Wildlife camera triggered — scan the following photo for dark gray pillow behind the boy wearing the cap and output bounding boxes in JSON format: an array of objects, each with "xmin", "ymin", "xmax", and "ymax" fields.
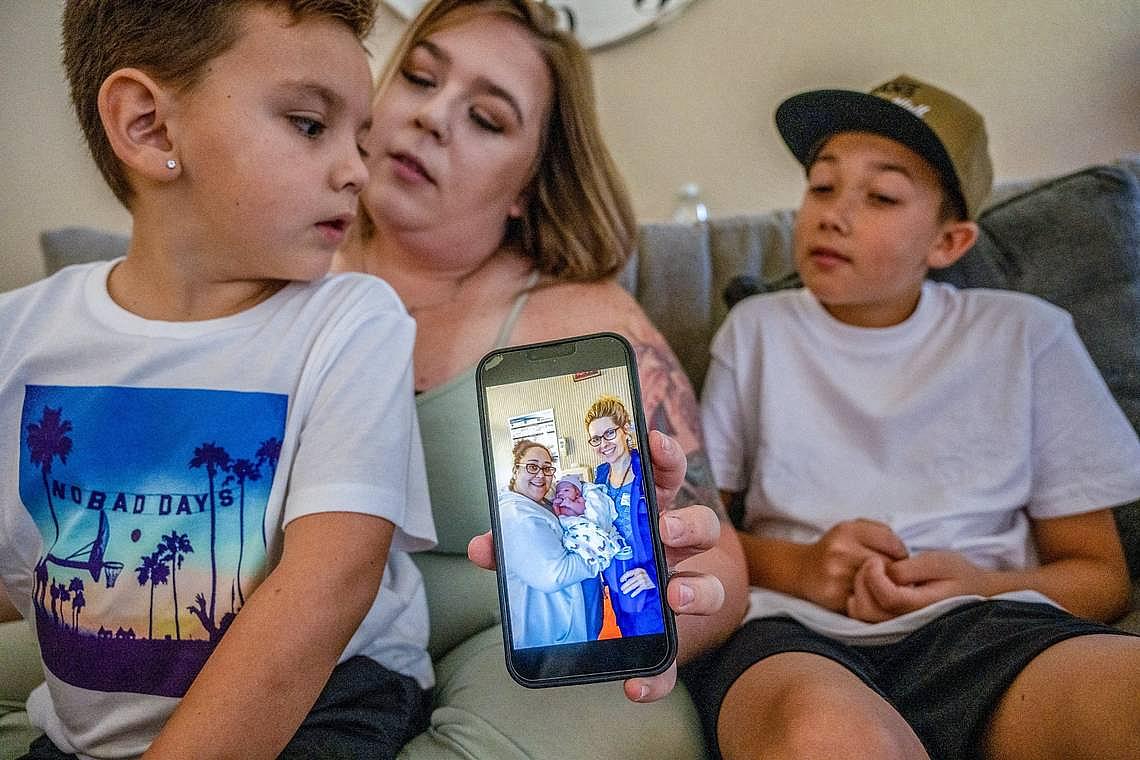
[{"xmin": 931, "ymin": 166, "xmax": 1140, "ymax": 578}]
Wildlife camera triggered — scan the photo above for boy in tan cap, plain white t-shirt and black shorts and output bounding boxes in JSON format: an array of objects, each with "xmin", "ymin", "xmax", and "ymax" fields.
[{"xmin": 686, "ymin": 76, "xmax": 1140, "ymax": 758}]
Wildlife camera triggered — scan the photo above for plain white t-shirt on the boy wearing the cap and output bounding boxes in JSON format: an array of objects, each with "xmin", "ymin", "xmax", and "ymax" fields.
[{"xmin": 701, "ymin": 283, "xmax": 1140, "ymax": 641}]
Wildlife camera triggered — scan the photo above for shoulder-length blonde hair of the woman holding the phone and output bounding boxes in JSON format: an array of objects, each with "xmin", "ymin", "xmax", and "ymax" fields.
[{"xmin": 360, "ymin": 0, "xmax": 637, "ymax": 281}]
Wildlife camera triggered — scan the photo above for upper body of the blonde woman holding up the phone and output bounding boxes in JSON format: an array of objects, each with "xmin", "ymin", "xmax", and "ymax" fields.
[{"xmin": 340, "ymin": 0, "xmax": 746, "ymax": 701}]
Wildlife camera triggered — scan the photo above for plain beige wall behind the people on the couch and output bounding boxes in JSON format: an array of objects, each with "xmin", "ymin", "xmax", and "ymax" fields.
[{"xmin": 0, "ymin": 0, "xmax": 1140, "ymax": 291}]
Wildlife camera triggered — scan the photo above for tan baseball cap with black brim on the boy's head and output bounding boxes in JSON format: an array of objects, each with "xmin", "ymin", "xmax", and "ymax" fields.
[{"xmin": 775, "ymin": 74, "xmax": 993, "ymax": 220}]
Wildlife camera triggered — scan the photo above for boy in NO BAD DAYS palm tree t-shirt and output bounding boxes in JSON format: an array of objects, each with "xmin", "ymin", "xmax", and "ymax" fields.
[{"xmin": 0, "ymin": 0, "xmax": 434, "ymax": 758}]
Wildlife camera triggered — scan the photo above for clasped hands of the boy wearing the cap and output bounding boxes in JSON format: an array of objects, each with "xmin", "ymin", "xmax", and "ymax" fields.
[{"xmin": 800, "ymin": 518, "xmax": 983, "ymax": 623}]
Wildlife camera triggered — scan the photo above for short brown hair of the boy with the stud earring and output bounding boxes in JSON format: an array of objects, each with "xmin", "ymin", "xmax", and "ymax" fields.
[{"xmin": 63, "ymin": 0, "xmax": 378, "ymax": 207}]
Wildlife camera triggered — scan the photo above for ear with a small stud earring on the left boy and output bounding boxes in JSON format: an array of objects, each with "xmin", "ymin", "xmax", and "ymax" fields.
[{"xmin": 98, "ymin": 68, "xmax": 181, "ymax": 181}]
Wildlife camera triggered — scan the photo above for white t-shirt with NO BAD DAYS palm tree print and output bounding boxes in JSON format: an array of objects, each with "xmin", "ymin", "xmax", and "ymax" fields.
[{"xmin": 0, "ymin": 262, "xmax": 435, "ymax": 757}]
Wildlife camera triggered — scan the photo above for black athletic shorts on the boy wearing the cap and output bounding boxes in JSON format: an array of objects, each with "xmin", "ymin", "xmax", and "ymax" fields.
[{"xmin": 681, "ymin": 600, "xmax": 1131, "ymax": 760}]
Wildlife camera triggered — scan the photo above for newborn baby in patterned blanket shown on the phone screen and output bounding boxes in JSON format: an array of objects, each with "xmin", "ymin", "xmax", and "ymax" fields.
[{"xmin": 552, "ymin": 475, "xmax": 634, "ymax": 572}]
